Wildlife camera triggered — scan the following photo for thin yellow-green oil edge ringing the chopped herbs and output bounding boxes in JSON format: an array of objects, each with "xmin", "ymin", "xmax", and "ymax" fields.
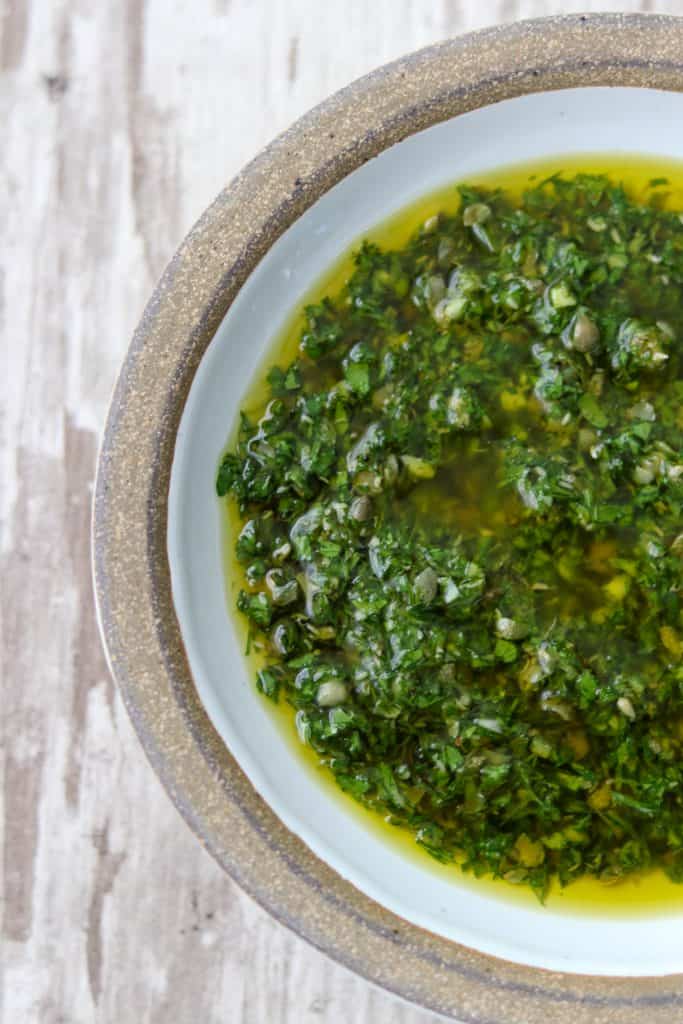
[{"xmin": 221, "ymin": 154, "xmax": 683, "ymax": 916}]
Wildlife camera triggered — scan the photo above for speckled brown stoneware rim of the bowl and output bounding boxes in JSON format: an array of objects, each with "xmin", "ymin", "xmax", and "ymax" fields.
[{"xmin": 92, "ymin": 14, "xmax": 683, "ymax": 1024}]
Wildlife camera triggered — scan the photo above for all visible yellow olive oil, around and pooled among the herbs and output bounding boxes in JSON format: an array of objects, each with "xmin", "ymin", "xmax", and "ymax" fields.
[{"xmin": 224, "ymin": 155, "xmax": 683, "ymax": 915}]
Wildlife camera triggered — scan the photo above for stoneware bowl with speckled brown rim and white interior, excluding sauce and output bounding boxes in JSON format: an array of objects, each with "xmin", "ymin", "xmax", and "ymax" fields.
[{"xmin": 93, "ymin": 15, "xmax": 683, "ymax": 1024}]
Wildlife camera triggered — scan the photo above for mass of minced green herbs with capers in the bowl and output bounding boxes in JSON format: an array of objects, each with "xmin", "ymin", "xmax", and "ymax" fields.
[{"xmin": 217, "ymin": 174, "xmax": 683, "ymax": 897}]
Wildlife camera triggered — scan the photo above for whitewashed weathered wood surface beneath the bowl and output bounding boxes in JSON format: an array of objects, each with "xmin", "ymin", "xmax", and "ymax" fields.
[{"xmin": 0, "ymin": 0, "xmax": 683, "ymax": 1024}]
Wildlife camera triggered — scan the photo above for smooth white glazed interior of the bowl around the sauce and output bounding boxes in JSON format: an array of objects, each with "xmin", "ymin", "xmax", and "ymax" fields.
[{"xmin": 168, "ymin": 88, "xmax": 683, "ymax": 975}]
